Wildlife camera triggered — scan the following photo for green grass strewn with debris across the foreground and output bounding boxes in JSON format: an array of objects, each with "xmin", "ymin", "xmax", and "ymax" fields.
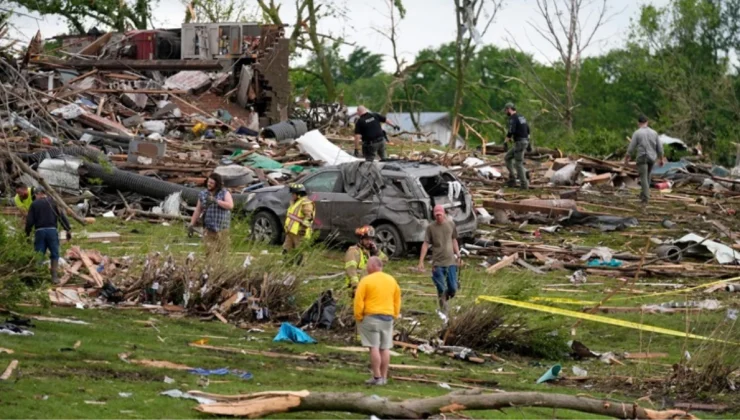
[{"xmin": 0, "ymin": 188, "xmax": 740, "ymax": 419}]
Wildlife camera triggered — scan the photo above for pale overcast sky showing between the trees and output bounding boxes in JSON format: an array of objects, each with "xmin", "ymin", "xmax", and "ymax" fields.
[{"xmin": 14, "ymin": 0, "xmax": 669, "ymax": 69}]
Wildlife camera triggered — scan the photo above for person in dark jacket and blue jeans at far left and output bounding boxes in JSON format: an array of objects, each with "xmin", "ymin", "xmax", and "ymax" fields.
[{"xmin": 26, "ymin": 187, "xmax": 72, "ymax": 284}]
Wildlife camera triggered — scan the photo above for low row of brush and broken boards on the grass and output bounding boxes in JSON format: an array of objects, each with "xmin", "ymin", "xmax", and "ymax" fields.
[{"xmin": 49, "ymin": 246, "xmax": 297, "ymax": 323}]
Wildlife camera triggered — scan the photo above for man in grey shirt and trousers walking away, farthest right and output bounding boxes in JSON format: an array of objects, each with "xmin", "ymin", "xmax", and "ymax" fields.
[{"xmin": 624, "ymin": 115, "xmax": 665, "ymax": 205}]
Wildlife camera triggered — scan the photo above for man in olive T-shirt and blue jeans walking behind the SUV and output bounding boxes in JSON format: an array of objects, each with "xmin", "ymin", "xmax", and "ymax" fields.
[{"xmin": 419, "ymin": 204, "xmax": 460, "ymax": 313}]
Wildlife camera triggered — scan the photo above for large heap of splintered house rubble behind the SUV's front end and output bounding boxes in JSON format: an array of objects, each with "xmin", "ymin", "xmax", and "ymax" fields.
[{"xmin": 0, "ymin": 25, "xmax": 364, "ymax": 220}]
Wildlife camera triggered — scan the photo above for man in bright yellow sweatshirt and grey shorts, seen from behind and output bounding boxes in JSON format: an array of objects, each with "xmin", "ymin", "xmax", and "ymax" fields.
[{"xmin": 355, "ymin": 257, "xmax": 401, "ymax": 385}]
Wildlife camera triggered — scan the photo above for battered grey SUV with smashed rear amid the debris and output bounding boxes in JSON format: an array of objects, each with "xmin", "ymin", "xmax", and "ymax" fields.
[{"xmin": 245, "ymin": 161, "xmax": 477, "ymax": 257}]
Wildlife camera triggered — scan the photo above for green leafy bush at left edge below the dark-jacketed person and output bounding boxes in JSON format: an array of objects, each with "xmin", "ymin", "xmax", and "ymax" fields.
[{"xmin": 0, "ymin": 219, "xmax": 49, "ymax": 306}]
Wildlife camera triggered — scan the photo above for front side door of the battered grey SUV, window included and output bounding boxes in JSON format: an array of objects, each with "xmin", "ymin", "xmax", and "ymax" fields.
[{"xmin": 303, "ymin": 170, "xmax": 341, "ymax": 238}]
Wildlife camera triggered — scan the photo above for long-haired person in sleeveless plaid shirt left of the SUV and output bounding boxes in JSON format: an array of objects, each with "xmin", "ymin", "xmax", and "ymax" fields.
[{"xmin": 189, "ymin": 173, "xmax": 234, "ymax": 256}]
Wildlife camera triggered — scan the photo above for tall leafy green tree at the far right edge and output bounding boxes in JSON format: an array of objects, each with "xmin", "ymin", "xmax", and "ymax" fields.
[{"xmin": 633, "ymin": 0, "xmax": 740, "ymax": 163}]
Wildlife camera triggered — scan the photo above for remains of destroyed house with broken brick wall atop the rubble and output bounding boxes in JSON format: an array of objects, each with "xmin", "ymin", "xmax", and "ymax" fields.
[{"xmin": 39, "ymin": 22, "xmax": 290, "ymax": 127}]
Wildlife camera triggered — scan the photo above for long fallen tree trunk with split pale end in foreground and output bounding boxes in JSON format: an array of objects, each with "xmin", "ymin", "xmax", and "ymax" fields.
[{"xmin": 196, "ymin": 390, "xmax": 696, "ymax": 420}]
